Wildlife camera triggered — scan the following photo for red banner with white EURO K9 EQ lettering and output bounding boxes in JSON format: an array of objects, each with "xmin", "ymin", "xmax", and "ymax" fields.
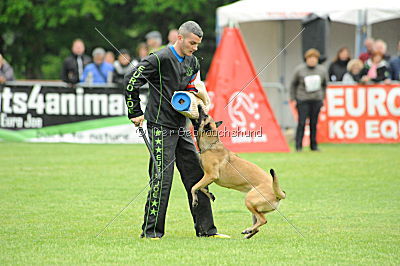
[{"xmin": 317, "ymin": 84, "xmax": 400, "ymax": 143}]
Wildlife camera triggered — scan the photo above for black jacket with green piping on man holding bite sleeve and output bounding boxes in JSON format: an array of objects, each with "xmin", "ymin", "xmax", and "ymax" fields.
[{"xmin": 124, "ymin": 47, "xmax": 200, "ymax": 128}]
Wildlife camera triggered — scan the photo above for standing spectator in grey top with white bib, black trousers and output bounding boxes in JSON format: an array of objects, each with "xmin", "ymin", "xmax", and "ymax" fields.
[{"xmin": 290, "ymin": 48, "xmax": 328, "ymax": 151}]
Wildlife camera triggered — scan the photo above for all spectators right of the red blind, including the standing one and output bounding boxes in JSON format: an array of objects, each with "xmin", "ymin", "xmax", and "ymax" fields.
[{"xmin": 290, "ymin": 39, "xmax": 400, "ymax": 152}]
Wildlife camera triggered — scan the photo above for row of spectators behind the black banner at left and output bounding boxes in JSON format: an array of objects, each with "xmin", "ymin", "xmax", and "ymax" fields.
[{"xmin": 61, "ymin": 29, "xmax": 178, "ymax": 87}]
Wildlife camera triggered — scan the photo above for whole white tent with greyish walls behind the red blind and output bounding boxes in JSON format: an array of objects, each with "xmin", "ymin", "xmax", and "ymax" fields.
[{"xmin": 217, "ymin": 0, "xmax": 400, "ymax": 126}]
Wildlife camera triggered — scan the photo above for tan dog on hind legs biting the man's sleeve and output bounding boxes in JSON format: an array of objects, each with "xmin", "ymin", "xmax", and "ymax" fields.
[{"xmin": 191, "ymin": 105, "xmax": 286, "ymax": 239}]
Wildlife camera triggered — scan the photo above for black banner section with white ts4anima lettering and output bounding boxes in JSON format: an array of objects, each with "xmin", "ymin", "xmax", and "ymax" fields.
[{"xmin": 0, "ymin": 81, "xmax": 147, "ymax": 130}]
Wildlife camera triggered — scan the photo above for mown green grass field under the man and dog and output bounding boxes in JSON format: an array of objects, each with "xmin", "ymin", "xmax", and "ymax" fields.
[{"xmin": 0, "ymin": 143, "xmax": 400, "ymax": 265}]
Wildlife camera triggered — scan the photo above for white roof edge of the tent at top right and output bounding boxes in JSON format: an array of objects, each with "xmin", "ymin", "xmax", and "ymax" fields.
[{"xmin": 217, "ymin": 0, "xmax": 400, "ymax": 27}]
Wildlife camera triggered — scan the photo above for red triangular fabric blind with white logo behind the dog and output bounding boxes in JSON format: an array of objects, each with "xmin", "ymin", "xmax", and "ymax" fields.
[{"xmin": 206, "ymin": 28, "xmax": 289, "ymax": 152}]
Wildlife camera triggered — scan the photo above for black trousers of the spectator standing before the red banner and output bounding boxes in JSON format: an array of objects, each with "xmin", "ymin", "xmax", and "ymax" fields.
[{"xmin": 296, "ymin": 100, "xmax": 322, "ymax": 150}]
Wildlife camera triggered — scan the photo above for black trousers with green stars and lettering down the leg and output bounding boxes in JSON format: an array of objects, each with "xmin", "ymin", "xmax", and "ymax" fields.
[{"xmin": 141, "ymin": 124, "xmax": 217, "ymax": 237}]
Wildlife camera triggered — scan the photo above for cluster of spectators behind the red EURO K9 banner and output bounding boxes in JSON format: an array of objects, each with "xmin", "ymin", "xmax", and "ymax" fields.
[{"xmin": 328, "ymin": 38, "xmax": 400, "ymax": 84}]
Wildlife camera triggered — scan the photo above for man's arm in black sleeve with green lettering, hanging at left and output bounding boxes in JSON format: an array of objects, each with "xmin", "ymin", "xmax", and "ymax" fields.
[{"xmin": 124, "ymin": 55, "xmax": 157, "ymax": 125}]
